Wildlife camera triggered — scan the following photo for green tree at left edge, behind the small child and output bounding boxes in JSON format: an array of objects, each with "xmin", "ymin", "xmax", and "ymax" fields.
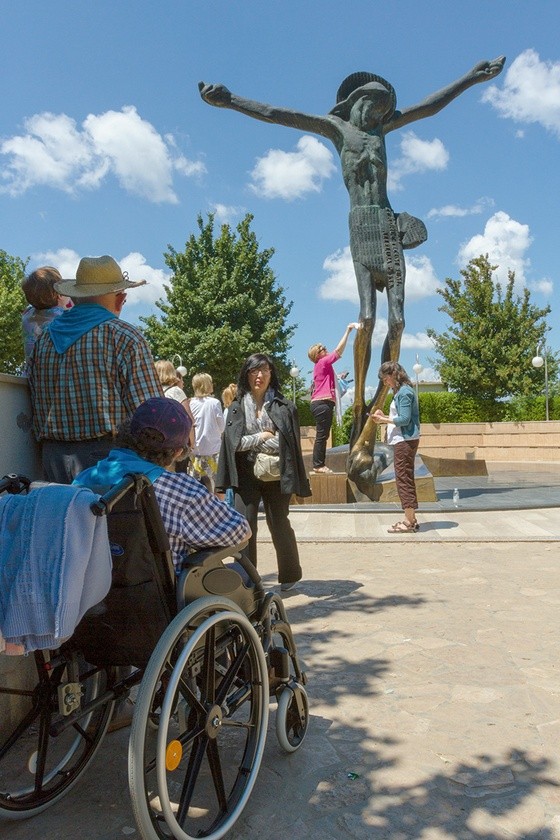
[{"xmin": 0, "ymin": 250, "xmax": 27, "ymax": 374}]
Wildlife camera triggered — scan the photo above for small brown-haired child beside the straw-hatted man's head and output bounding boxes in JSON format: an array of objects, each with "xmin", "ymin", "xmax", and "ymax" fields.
[{"xmin": 21, "ymin": 265, "xmax": 72, "ymax": 366}]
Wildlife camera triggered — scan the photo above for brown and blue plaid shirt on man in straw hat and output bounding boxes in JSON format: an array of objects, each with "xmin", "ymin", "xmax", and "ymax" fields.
[{"xmin": 29, "ymin": 318, "xmax": 163, "ymax": 441}]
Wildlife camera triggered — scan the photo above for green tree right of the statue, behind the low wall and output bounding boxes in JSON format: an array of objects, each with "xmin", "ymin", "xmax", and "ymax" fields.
[{"xmin": 427, "ymin": 255, "xmax": 558, "ymax": 400}]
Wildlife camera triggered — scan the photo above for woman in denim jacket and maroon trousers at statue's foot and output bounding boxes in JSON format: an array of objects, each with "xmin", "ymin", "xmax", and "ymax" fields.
[{"xmin": 371, "ymin": 362, "xmax": 420, "ymax": 534}]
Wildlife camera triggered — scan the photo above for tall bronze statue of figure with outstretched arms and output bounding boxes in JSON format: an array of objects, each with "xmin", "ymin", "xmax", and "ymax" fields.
[{"xmin": 198, "ymin": 57, "xmax": 505, "ymax": 495}]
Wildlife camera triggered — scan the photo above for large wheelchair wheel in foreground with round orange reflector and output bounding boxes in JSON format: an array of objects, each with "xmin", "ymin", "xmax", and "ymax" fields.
[{"xmin": 129, "ymin": 597, "xmax": 269, "ymax": 840}]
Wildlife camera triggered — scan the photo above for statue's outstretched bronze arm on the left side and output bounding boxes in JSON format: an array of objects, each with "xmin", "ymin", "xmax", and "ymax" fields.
[{"xmin": 198, "ymin": 82, "xmax": 335, "ymax": 140}]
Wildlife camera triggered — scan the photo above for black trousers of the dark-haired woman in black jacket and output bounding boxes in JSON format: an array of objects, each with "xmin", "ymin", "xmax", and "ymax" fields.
[{"xmin": 235, "ymin": 456, "xmax": 302, "ymax": 583}]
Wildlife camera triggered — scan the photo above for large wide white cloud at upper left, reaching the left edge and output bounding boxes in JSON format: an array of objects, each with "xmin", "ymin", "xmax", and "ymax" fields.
[{"xmin": 0, "ymin": 106, "xmax": 206, "ymax": 203}]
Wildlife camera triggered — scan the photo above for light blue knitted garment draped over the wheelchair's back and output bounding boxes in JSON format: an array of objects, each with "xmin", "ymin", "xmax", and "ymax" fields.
[{"xmin": 0, "ymin": 484, "xmax": 112, "ymax": 653}]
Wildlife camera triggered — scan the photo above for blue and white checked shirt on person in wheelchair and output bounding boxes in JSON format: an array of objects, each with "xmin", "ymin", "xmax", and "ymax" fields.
[{"xmin": 154, "ymin": 470, "xmax": 250, "ymax": 567}]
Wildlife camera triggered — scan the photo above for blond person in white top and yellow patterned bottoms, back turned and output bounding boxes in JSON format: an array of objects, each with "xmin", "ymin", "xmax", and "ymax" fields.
[{"xmin": 189, "ymin": 373, "xmax": 224, "ymax": 493}]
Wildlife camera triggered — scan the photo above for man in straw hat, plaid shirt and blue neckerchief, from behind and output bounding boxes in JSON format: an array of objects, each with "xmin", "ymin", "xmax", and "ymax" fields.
[{"xmin": 29, "ymin": 256, "xmax": 162, "ymax": 484}]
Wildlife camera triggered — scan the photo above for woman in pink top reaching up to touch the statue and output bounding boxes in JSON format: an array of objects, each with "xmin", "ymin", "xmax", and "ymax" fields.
[{"xmin": 307, "ymin": 324, "xmax": 359, "ymax": 473}]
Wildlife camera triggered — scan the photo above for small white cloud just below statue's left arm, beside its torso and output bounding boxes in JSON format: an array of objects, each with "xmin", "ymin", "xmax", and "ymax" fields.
[{"xmin": 250, "ymin": 135, "xmax": 336, "ymax": 201}]
